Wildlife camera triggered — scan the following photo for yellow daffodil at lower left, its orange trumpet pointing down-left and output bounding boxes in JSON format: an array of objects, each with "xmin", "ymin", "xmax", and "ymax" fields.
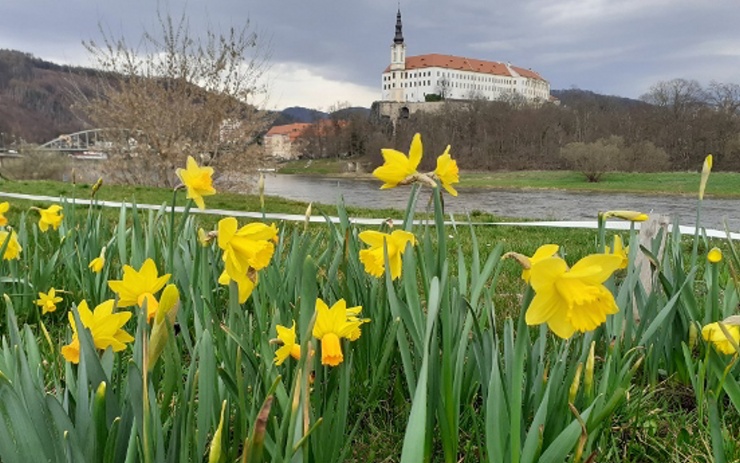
[{"xmin": 62, "ymin": 299, "xmax": 134, "ymax": 363}]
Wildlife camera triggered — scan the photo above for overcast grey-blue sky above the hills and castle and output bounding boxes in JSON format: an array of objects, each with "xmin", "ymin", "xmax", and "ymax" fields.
[{"xmin": 0, "ymin": 0, "xmax": 740, "ymax": 109}]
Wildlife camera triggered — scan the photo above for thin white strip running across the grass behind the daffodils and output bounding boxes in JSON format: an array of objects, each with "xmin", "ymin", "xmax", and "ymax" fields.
[{"xmin": 0, "ymin": 191, "xmax": 740, "ymax": 240}]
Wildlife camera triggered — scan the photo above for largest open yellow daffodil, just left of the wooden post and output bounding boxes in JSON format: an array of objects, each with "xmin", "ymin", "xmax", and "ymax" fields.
[{"xmin": 525, "ymin": 254, "xmax": 622, "ymax": 339}]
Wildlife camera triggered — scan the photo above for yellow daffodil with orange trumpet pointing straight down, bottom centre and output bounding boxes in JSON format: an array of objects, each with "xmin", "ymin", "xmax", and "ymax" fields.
[{"xmin": 313, "ymin": 299, "xmax": 361, "ymax": 367}]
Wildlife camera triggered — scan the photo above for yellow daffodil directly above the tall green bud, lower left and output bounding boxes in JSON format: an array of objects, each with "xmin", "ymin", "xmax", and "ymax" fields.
[{"xmin": 108, "ymin": 259, "xmax": 170, "ymax": 321}]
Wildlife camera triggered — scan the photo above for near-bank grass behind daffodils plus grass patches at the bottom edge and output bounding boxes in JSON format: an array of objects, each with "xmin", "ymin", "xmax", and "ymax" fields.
[{"xmin": 0, "ymin": 179, "xmax": 740, "ymax": 462}]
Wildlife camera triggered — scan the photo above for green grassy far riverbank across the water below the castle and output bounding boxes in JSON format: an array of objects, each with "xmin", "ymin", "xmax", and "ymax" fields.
[{"xmin": 278, "ymin": 158, "xmax": 740, "ymax": 198}]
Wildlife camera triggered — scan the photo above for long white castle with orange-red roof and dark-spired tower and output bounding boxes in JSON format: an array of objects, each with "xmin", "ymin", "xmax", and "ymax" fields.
[{"xmin": 381, "ymin": 9, "xmax": 550, "ymax": 102}]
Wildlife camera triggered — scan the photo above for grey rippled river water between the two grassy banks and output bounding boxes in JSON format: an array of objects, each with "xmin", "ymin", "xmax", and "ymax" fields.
[{"xmin": 265, "ymin": 174, "xmax": 740, "ymax": 232}]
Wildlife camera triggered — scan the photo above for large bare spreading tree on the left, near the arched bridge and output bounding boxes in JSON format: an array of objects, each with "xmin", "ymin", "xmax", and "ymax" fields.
[{"xmin": 77, "ymin": 7, "xmax": 268, "ymax": 185}]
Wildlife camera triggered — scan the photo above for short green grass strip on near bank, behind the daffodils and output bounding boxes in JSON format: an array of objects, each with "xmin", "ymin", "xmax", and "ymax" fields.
[{"xmin": 0, "ymin": 177, "xmax": 726, "ymax": 322}]
